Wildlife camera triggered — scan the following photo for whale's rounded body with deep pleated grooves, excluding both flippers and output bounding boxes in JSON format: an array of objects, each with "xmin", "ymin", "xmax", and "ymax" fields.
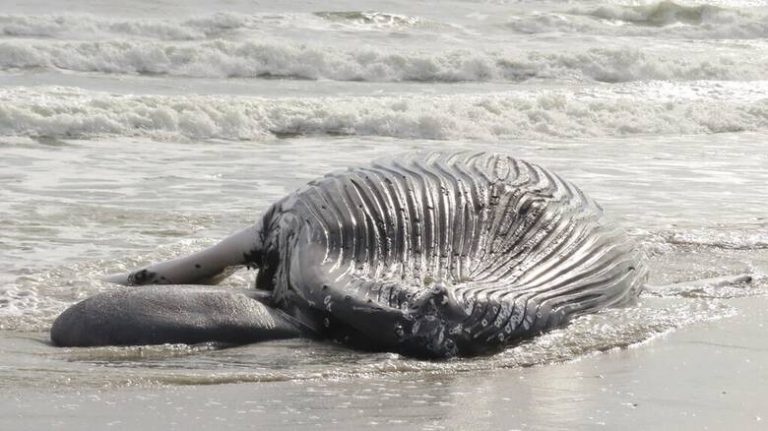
[{"xmin": 257, "ymin": 153, "xmax": 646, "ymax": 356}]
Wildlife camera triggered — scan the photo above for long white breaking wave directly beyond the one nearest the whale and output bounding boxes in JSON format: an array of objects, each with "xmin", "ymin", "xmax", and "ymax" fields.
[{"xmin": 0, "ymin": 40, "xmax": 768, "ymax": 82}]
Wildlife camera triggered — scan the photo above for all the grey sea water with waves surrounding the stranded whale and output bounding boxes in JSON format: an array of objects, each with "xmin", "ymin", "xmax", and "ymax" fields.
[{"xmin": 0, "ymin": 0, "xmax": 768, "ymax": 428}]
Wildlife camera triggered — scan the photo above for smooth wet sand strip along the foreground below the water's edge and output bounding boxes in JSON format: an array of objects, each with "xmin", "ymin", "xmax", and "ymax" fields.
[{"xmin": 0, "ymin": 296, "xmax": 768, "ymax": 431}]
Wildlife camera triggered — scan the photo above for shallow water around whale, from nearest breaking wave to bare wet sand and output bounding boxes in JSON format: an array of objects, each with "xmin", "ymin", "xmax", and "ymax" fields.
[{"xmin": 0, "ymin": 134, "xmax": 768, "ymax": 387}]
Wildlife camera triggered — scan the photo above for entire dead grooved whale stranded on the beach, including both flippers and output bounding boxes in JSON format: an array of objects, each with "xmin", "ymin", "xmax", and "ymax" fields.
[{"xmin": 51, "ymin": 153, "xmax": 660, "ymax": 358}]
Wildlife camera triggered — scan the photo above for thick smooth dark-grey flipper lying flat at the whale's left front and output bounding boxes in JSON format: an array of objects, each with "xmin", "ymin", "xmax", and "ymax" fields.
[{"xmin": 51, "ymin": 286, "xmax": 303, "ymax": 346}]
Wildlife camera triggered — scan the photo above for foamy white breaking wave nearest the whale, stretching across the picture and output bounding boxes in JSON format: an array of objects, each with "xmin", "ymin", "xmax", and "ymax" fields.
[{"xmin": 0, "ymin": 83, "xmax": 768, "ymax": 140}]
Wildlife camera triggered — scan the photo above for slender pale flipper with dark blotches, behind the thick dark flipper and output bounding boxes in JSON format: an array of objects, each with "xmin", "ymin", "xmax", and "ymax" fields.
[{"xmin": 105, "ymin": 226, "xmax": 260, "ymax": 286}]
